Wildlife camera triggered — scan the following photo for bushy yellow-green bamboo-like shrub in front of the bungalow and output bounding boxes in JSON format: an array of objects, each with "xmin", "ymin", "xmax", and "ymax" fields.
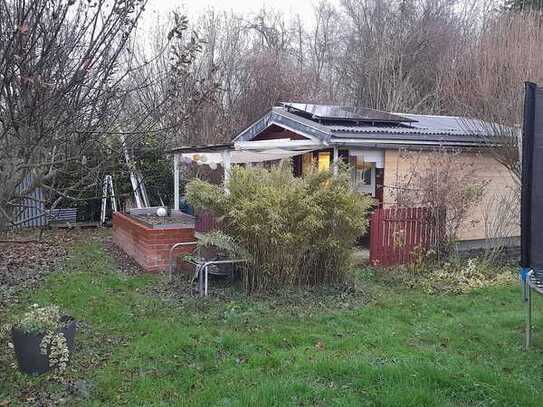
[{"xmin": 187, "ymin": 161, "xmax": 373, "ymax": 291}]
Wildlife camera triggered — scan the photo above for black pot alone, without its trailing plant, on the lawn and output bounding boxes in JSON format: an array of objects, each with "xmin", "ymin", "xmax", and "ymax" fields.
[{"xmin": 11, "ymin": 317, "xmax": 76, "ymax": 375}]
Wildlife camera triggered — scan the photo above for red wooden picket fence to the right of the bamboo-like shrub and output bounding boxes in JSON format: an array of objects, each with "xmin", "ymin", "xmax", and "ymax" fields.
[{"xmin": 370, "ymin": 208, "xmax": 446, "ymax": 266}]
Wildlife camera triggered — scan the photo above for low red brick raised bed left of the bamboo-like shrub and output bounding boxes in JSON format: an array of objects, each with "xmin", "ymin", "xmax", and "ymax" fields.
[{"xmin": 113, "ymin": 212, "xmax": 195, "ymax": 273}]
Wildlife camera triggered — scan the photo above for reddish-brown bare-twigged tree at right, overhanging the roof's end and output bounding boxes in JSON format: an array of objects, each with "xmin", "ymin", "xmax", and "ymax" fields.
[{"xmin": 438, "ymin": 12, "xmax": 543, "ymax": 182}]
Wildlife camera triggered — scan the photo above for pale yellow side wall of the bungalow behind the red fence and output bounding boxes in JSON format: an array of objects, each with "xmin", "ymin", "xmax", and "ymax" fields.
[{"xmin": 383, "ymin": 150, "xmax": 520, "ymax": 240}]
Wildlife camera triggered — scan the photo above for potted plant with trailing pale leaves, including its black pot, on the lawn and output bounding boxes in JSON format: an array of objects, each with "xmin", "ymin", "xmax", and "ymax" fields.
[{"xmin": 2, "ymin": 304, "xmax": 76, "ymax": 375}]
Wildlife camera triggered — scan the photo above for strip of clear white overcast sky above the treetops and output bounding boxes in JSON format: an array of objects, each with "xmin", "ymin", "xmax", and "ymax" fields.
[{"xmin": 145, "ymin": 0, "xmax": 326, "ymax": 28}]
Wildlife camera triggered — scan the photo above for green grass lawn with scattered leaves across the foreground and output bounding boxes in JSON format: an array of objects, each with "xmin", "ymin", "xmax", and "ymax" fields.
[{"xmin": 0, "ymin": 241, "xmax": 543, "ymax": 407}]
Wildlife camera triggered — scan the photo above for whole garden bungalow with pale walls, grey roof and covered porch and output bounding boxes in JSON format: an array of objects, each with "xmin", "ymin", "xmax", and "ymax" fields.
[{"xmin": 172, "ymin": 103, "xmax": 514, "ymax": 247}]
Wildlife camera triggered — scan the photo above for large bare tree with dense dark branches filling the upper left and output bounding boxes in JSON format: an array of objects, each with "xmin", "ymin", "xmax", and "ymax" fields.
[{"xmin": 0, "ymin": 0, "xmax": 225, "ymax": 225}]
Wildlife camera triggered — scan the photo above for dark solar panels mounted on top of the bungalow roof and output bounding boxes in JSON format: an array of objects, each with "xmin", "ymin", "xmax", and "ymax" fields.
[{"xmin": 282, "ymin": 102, "xmax": 416, "ymax": 123}]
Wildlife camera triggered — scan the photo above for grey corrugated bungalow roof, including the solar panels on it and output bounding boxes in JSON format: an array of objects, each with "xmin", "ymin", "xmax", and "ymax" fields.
[{"xmin": 234, "ymin": 102, "xmax": 510, "ymax": 148}]
